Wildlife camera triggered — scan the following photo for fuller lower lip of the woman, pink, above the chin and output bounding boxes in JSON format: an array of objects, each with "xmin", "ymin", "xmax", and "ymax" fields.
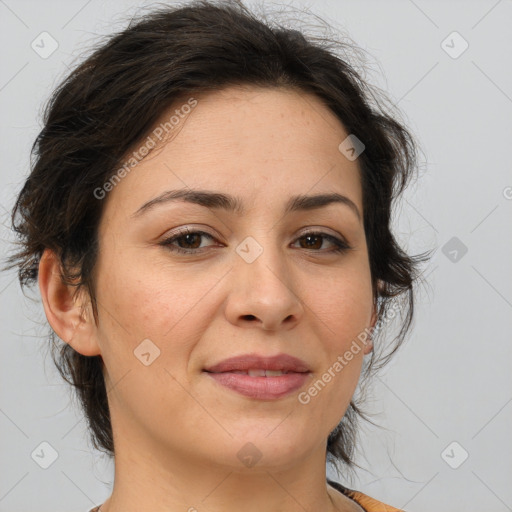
[{"xmin": 205, "ymin": 372, "xmax": 310, "ymax": 400}]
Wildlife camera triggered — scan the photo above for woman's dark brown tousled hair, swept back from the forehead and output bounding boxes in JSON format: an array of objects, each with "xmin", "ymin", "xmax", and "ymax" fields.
[{"xmin": 6, "ymin": 0, "xmax": 425, "ymax": 476}]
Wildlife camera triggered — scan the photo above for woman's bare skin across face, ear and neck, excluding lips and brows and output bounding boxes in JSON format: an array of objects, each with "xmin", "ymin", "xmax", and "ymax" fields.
[{"xmin": 39, "ymin": 86, "xmax": 376, "ymax": 512}]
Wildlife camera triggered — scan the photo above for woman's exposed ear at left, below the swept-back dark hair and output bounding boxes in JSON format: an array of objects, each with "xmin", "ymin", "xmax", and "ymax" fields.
[{"xmin": 38, "ymin": 249, "xmax": 101, "ymax": 356}]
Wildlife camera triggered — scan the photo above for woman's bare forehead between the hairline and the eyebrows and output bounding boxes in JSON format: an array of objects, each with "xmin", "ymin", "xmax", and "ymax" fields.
[{"xmin": 102, "ymin": 86, "xmax": 362, "ymax": 220}]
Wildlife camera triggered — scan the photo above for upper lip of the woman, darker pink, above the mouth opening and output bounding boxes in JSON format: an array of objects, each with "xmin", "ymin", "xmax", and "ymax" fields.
[{"xmin": 205, "ymin": 354, "xmax": 311, "ymax": 373}]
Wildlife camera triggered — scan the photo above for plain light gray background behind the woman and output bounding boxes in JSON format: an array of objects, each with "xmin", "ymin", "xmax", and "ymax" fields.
[{"xmin": 0, "ymin": 0, "xmax": 512, "ymax": 512}]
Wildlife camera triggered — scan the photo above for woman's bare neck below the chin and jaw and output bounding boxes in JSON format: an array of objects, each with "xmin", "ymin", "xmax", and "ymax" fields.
[{"xmin": 99, "ymin": 432, "xmax": 354, "ymax": 512}]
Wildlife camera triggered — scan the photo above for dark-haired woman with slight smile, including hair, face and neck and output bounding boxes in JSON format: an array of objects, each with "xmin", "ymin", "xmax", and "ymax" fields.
[{"xmin": 6, "ymin": 1, "xmax": 422, "ymax": 512}]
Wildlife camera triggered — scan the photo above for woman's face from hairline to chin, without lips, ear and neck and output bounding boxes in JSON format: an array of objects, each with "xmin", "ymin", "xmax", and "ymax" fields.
[{"xmin": 89, "ymin": 87, "xmax": 374, "ymax": 469}]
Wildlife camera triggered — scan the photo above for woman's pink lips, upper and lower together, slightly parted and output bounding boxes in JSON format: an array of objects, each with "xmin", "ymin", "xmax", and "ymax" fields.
[{"xmin": 204, "ymin": 354, "xmax": 311, "ymax": 400}]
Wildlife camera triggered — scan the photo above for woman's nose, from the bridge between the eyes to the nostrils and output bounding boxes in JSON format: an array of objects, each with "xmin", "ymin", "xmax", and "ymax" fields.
[{"xmin": 225, "ymin": 241, "xmax": 304, "ymax": 331}]
